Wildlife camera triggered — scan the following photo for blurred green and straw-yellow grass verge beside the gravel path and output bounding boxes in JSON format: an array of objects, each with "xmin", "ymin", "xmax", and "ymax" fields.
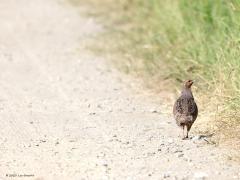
[{"xmin": 71, "ymin": 0, "xmax": 240, "ymax": 155}]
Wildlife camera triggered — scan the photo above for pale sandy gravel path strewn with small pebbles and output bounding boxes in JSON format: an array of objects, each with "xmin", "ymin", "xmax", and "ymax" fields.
[{"xmin": 0, "ymin": 0, "xmax": 240, "ymax": 180}]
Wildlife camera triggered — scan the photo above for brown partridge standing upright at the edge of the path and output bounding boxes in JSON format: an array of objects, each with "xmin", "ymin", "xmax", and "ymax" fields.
[{"xmin": 173, "ymin": 80, "xmax": 198, "ymax": 139}]
